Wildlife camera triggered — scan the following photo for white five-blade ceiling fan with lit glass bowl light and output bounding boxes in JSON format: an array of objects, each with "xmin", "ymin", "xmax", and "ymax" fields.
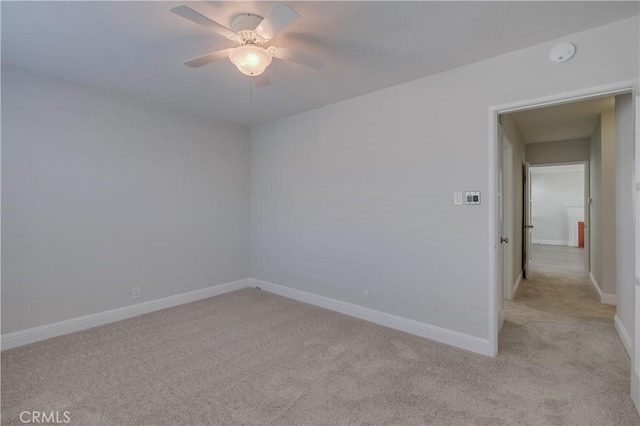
[{"xmin": 171, "ymin": 3, "xmax": 325, "ymax": 87}]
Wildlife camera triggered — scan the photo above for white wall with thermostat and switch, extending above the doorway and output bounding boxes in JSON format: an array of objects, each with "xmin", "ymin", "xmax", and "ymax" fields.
[{"xmin": 251, "ymin": 17, "xmax": 639, "ymax": 339}]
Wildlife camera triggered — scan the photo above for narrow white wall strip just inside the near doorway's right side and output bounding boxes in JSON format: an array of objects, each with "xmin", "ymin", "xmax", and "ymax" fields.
[{"xmin": 615, "ymin": 94, "xmax": 638, "ymax": 348}]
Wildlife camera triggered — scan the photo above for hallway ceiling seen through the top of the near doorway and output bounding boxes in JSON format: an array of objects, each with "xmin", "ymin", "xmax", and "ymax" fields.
[{"xmin": 511, "ymin": 96, "xmax": 615, "ymax": 144}]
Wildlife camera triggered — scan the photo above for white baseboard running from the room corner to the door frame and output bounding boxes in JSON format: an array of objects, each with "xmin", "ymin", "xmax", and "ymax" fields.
[{"xmin": 251, "ymin": 278, "xmax": 491, "ymax": 356}]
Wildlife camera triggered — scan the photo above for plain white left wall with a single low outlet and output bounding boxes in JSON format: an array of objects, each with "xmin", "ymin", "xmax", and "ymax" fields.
[{"xmin": 2, "ymin": 67, "xmax": 250, "ymax": 334}]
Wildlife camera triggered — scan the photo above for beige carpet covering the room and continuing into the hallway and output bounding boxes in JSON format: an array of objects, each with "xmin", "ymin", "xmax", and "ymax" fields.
[{"xmin": 2, "ymin": 275, "xmax": 640, "ymax": 426}]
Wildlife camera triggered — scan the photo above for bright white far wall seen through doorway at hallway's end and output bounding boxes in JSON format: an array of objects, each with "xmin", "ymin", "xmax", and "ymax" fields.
[{"xmin": 531, "ymin": 166, "xmax": 584, "ymax": 247}]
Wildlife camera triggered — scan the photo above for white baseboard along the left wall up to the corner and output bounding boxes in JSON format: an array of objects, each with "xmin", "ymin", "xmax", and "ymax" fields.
[{"xmin": 0, "ymin": 278, "xmax": 250, "ymax": 350}]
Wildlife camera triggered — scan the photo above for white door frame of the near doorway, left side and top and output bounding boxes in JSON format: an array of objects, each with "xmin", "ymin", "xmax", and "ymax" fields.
[{"xmin": 487, "ymin": 80, "xmax": 640, "ymax": 358}]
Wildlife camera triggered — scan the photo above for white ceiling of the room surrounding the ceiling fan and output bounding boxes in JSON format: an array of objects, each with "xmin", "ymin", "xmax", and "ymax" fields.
[{"xmin": 1, "ymin": 1, "xmax": 639, "ymax": 125}]
